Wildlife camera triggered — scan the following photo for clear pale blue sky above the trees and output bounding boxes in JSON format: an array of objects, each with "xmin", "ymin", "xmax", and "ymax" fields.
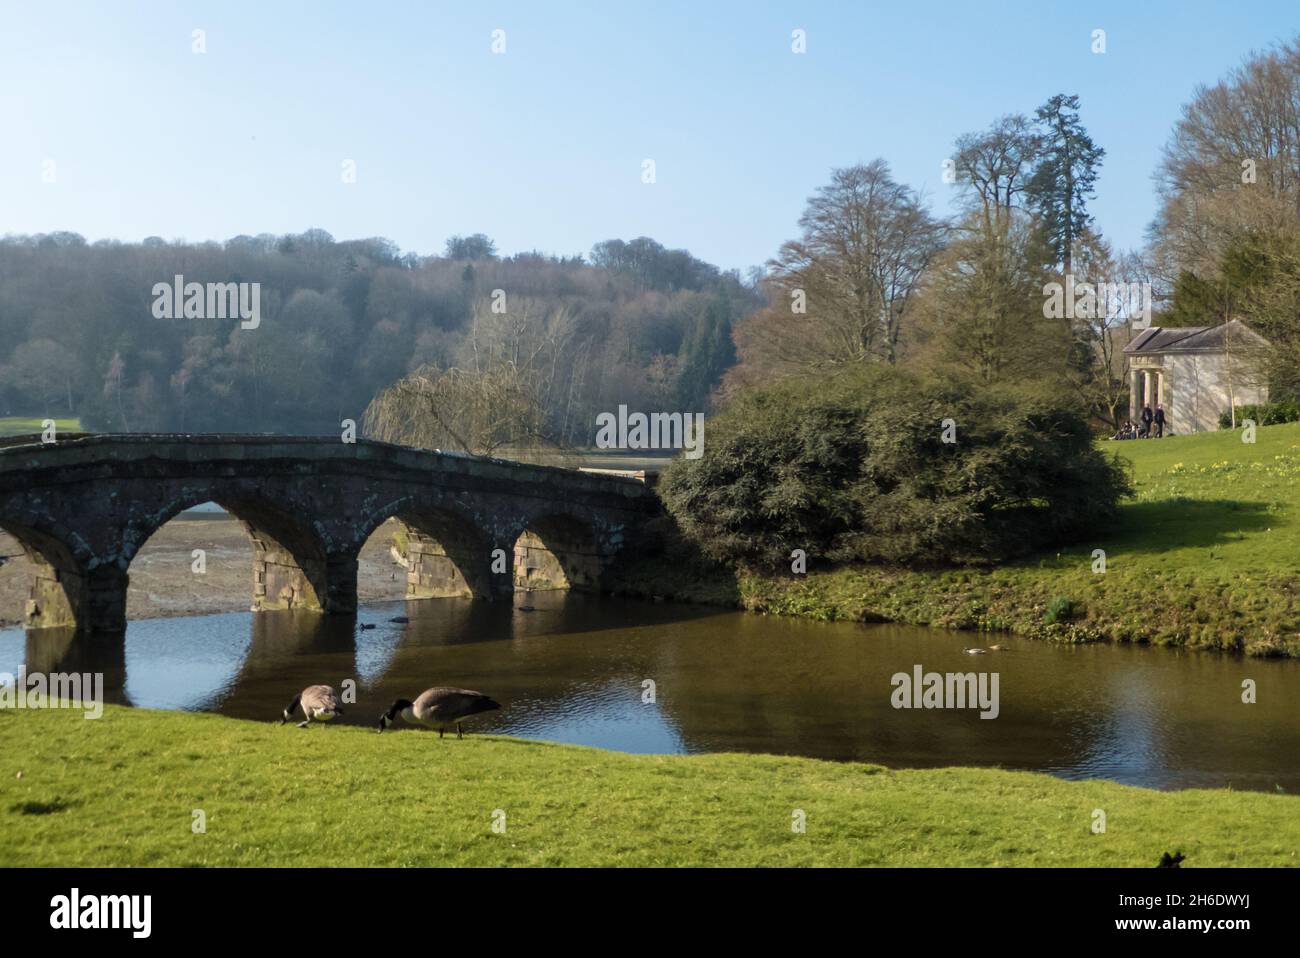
[{"xmin": 0, "ymin": 0, "xmax": 1300, "ymax": 268}]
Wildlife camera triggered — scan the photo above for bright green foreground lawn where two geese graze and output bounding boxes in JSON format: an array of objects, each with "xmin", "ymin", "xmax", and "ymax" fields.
[{"xmin": 0, "ymin": 706, "xmax": 1300, "ymax": 867}]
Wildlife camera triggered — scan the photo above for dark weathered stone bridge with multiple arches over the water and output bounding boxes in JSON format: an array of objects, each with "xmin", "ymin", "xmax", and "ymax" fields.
[{"xmin": 0, "ymin": 434, "xmax": 657, "ymax": 632}]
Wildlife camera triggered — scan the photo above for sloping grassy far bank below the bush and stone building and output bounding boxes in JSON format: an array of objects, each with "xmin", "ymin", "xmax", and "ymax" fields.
[{"xmin": 611, "ymin": 424, "xmax": 1300, "ymax": 656}]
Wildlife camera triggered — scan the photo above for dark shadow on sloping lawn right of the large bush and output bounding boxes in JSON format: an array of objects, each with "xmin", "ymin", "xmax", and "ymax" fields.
[{"xmin": 1106, "ymin": 499, "xmax": 1284, "ymax": 552}]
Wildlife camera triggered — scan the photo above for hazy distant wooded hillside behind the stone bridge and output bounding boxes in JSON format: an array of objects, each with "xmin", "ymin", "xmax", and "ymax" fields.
[{"xmin": 0, "ymin": 230, "xmax": 757, "ymax": 436}]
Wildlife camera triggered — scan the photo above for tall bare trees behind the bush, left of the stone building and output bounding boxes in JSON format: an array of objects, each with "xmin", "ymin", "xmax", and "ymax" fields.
[{"xmin": 724, "ymin": 94, "xmax": 1148, "ymax": 425}]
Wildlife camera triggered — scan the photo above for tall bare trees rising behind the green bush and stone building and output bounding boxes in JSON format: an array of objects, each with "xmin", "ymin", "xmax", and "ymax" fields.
[{"xmin": 724, "ymin": 40, "xmax": 1300, "ymax": 432}]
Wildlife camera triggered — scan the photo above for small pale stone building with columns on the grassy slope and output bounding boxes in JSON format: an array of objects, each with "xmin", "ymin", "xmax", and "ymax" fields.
[{"xmin": 1125, "ymin": 320, "xmax": 1269, "ymax": 435}]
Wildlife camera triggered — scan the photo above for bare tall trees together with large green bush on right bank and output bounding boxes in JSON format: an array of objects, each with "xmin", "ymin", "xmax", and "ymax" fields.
[{"xmin": 651, "ymin": 43, "xmax": 1300, "ymax": 572}]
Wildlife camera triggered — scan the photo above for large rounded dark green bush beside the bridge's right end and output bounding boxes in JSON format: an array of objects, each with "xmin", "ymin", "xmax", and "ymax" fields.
[{"xmin": 660, "ymin": 367, "xmax": 1130, "ymax": 568}]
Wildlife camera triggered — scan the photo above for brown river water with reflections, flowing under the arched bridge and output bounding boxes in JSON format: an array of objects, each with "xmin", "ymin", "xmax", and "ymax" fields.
[{"xmin": 0, "ymin": 593, "xmax": 1300, "ymax": 792}]
